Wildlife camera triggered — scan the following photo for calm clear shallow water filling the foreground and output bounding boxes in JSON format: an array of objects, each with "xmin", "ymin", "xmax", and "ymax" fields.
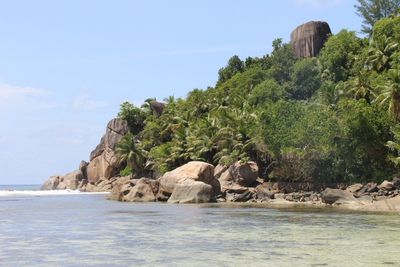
[{"xmin": 0, "ymin": 187, "xmax": 400, "ymax": 266}]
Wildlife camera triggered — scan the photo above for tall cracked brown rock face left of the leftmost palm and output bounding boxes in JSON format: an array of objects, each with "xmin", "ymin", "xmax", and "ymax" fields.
[{"xmin": 86, "ymin": 118, "xmax": 129, "ymax": 184}]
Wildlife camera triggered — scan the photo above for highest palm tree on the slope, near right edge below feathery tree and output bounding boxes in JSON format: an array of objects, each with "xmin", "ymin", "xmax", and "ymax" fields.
[{"xmin": 366, "ymin": 36, "xmax": 399, "ymax": 72}]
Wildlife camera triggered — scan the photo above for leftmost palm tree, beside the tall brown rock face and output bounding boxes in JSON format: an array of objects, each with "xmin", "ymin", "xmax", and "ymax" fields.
[{"xmin": 115, "ymin": 132, "xmax": 149, "ymax": 177}]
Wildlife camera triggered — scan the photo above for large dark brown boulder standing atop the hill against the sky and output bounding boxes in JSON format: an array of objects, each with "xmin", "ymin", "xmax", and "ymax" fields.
[{"xmin": 290, "ymin": 21, "xmax": 331, "ymax": 58}]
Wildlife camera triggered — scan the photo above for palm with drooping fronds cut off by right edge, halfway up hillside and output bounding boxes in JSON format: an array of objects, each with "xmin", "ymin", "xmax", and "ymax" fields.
[{"xmin": 374, "ymin": 69, "xmax": 400, "ymax": 121}]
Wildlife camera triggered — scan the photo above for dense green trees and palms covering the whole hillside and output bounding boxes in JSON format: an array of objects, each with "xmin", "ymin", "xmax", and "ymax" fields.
[{"xmin": 117, "ymin": 8, "xmax": 400, "ymax": 183}]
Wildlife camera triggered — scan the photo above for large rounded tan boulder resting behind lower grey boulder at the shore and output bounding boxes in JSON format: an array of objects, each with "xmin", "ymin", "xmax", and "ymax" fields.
[{"xmin": 159, "ymin": 161, "xmax": 214, "ymax": 194}]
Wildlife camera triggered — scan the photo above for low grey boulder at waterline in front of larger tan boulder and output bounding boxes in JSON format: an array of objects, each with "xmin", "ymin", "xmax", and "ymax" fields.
[{"xmin": 168, "ymin": 180, "xmax": 214, "ymax": 203}]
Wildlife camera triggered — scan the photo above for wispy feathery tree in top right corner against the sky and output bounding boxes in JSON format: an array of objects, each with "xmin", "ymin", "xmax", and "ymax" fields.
[{"xmin": 354, "ymin": 0, "xmax": 400, "ymax": 35}]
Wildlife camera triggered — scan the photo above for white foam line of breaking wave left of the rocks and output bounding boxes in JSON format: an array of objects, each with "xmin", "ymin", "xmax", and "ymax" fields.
[{"xmin": 0, "ymin": 189, "xmax": 109, "ymax": 197}]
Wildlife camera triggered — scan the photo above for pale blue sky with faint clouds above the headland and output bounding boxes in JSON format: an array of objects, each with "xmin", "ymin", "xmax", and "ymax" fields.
[{"xmin": 0, "ymin": 0, "xmax": 361, "ymax": 184}]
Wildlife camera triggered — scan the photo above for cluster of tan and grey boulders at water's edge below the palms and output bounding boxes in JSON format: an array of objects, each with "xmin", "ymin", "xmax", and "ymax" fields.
[{"xmin": 109, "ymin": 161, "xmax": 266, "ymax": 203}]
